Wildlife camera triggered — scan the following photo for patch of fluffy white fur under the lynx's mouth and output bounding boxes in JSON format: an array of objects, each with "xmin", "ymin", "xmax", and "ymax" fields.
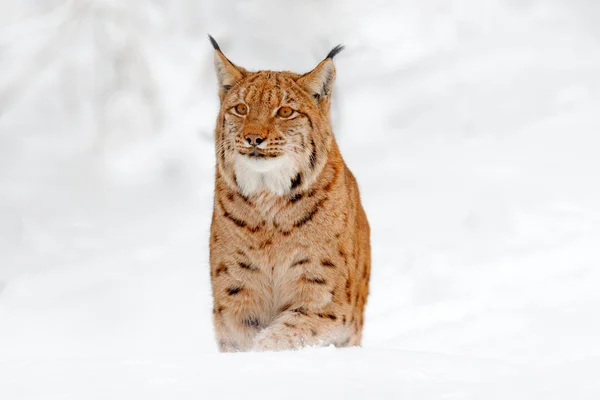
[{"xmin": 234, "ymin": 154, "xmax": 297, "ymax": 196}]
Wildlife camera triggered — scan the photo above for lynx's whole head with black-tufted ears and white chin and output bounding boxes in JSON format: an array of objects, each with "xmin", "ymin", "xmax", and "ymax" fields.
[{"xmin": 209, "ymin": 36, "xmax": 343, "ymax": 196}]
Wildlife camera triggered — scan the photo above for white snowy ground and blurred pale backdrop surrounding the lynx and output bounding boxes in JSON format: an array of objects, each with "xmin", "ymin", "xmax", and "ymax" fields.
[{"xmin": 0, "ymin": 0, "xmax": 600, "ymax": 400}]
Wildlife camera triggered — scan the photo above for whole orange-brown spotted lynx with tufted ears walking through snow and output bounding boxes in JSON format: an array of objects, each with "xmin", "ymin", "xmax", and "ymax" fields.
[{"xmin": 209, "ymin": 36, "xmax": 371, "ymax": 352}]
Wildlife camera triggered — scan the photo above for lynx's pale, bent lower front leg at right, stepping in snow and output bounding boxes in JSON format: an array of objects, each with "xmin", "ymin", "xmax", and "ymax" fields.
[{"xmin": 253, "ymin": 308, "xmax": 350, "ymax": 351}]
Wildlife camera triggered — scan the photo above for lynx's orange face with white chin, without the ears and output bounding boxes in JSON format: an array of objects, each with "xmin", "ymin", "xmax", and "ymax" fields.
[{"xmin": 222, "ymin": 73, "xmax": 318, "ymax": 196}]
